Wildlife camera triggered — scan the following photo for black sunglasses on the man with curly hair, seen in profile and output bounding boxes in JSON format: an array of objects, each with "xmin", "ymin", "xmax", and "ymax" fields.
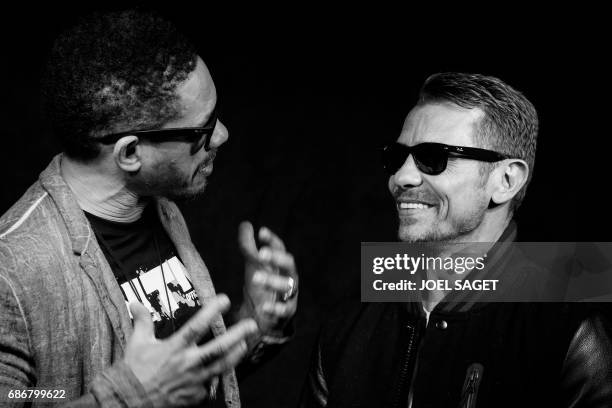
[{"xmin": 96, "ymin": 106, "xmax": 217, "ymax": 154}]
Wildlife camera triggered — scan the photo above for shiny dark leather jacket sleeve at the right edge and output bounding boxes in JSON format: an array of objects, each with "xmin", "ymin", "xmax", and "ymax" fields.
[{"xmin": 562, "ymin": 315, "xmax": 612, "ymax": 408}]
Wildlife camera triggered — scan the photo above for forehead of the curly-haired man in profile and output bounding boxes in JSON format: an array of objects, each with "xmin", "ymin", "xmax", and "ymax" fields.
[{"xmin": 176, "ymin": 57, "xmax": 217, "ymax": 126}]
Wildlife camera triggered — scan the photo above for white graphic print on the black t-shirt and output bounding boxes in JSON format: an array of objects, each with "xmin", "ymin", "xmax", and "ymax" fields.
[{"xmin": 121, "ymin": 256, "xmax": 201, "ymax": 338}]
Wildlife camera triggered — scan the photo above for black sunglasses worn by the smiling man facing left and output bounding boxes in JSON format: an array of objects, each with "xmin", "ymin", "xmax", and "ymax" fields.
[{"xmin": 382, "ymin": 143, "xmax": 509, "ymax": 176}]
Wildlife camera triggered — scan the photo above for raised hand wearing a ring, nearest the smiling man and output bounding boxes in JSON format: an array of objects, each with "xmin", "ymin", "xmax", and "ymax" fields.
[{"xmin": 238, "ymin": 222, "xmax": 298, "ymax": 335}]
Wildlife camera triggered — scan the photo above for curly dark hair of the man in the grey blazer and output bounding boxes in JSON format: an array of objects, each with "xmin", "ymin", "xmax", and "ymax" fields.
[{"xmin": 43, "ymin": 10, "xmax": 197, "ymax": 160}]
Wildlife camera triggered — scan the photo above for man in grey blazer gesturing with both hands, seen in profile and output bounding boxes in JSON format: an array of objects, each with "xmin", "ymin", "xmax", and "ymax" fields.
[{"xmin": 0, "ymin": 11, "xmax": 297, "ymax": 407}]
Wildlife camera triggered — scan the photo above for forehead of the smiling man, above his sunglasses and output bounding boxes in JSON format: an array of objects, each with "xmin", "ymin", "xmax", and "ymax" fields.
[{"xmin": 398, "ymin": 102, "xmax": 484, "ymax": 146}]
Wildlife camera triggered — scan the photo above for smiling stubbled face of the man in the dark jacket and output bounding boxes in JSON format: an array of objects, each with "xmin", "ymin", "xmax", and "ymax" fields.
[{"xmin": 386, "ymin": 102, "xmax": 520, "ymax": 242}]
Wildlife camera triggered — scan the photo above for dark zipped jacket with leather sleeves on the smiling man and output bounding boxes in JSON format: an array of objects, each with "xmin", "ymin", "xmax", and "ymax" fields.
[{"xmin": 302, "ymin": 227, "xmax": 612, "ymax": 408}]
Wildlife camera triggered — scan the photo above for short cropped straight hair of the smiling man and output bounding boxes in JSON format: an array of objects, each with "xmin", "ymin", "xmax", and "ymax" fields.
[{"xmin": 418, "ymin": 72, "xmax": 538, "ymax": 211}]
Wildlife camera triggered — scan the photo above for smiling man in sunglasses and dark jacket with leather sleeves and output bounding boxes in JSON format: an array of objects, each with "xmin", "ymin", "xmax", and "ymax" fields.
[{"xmin": 302, "ymin": 73, "xmax": 612, "ymax": 408}]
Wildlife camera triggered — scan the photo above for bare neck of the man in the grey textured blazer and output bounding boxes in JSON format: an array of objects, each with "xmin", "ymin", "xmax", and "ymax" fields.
[{"xmin": 61, "ymin": 155, "xmax": 147, "ymax": 222}]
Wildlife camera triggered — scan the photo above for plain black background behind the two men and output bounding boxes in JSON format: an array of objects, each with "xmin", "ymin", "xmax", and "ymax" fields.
[{"xmin": 0, "ymin": 2, "xmax": 610, "ymax": 407}]
